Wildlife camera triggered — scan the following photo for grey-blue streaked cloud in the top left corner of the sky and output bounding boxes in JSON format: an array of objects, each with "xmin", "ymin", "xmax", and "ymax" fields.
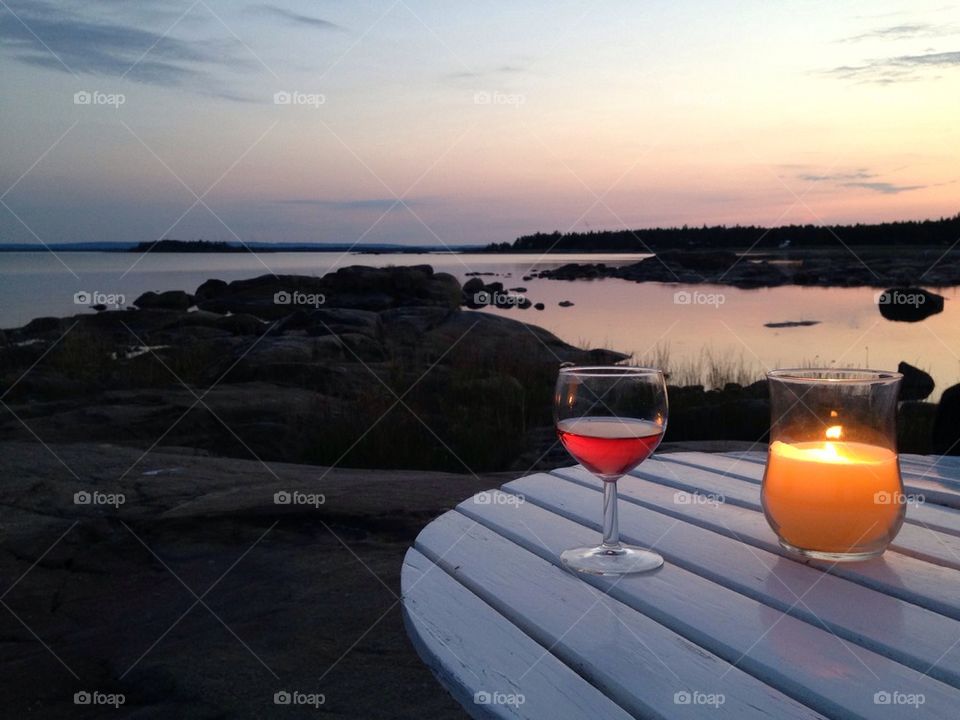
[{"xmin": 0, "ymin": 2, "xmax": 248, "ymax": 86}]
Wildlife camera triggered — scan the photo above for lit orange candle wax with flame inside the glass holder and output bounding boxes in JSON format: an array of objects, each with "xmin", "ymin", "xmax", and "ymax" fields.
[{"xmin": 763, "ymin": 425, "xmax": 904, "ymax": 553}]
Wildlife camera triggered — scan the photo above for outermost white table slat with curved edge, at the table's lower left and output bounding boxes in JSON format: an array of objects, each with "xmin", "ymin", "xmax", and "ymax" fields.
[{"xmin": 401, "ymin": 548, "xmax": 631, "ymax": 720}]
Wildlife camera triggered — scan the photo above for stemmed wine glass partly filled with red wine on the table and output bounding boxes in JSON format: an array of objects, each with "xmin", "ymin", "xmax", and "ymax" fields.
[{"xmin": 553, "ymin": 365, "xmax": 667, "ymax": 575}]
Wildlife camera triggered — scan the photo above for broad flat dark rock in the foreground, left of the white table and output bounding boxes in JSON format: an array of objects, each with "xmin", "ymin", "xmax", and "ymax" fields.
[{"xmin": 0, "ymin": 442, "xmax": 496, "ymax": 720}]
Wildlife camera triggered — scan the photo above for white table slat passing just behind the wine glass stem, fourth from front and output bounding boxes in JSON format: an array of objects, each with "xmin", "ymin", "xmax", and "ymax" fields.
[{"xmin": 498, "ymin": 475, "xmax": 960, "ymax": 688}]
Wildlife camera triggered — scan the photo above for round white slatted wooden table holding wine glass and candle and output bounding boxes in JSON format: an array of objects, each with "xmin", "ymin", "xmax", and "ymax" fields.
[{"xmin": 402, "ymin": 452, "xmax": 960, "ymax": 720}]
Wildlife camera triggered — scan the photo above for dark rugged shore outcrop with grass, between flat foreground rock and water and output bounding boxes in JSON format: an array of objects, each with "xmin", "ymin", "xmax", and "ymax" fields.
[{"xmin": 0, "ymin": 266, "xmax": 627, "ymax": 472}]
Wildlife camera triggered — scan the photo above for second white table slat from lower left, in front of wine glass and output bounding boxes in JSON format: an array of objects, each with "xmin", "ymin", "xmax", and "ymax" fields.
[{"xmin": 416, "ymin": 511, "xmax": 817, "ymax": 719}]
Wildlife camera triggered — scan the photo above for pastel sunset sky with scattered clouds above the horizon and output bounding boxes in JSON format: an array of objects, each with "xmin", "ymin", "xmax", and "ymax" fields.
[{"xmin": 0, "ymin": 0, "xmax": 960, "ymax": 246}]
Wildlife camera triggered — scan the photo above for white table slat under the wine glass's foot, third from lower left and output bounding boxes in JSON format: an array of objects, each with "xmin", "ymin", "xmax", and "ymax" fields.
[{"xmin": 459, "ymin": 486, "xmax": 960, "ymax": 718}]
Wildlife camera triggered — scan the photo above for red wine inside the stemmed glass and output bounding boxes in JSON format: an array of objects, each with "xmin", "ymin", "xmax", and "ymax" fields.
[{"xmin": 557, "ymin": 417, "xmax": 663, "ymax": 475}]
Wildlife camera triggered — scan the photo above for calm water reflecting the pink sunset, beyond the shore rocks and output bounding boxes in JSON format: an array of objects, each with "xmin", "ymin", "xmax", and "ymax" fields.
[{"xmin": 0, "ymin": 252, "xmax": 960, "ymax": 398}]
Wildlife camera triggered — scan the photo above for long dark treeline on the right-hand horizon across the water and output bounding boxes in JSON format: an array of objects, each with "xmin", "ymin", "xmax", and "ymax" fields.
[{"xmin": 486, "ymin": 214, "xmax": 960, "ymax": 252}]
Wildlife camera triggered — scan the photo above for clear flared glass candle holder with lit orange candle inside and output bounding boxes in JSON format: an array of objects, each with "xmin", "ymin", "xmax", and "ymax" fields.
[{"xmin": 761, "ymin": 370, "xmax": 906, "ymax": 562}]
